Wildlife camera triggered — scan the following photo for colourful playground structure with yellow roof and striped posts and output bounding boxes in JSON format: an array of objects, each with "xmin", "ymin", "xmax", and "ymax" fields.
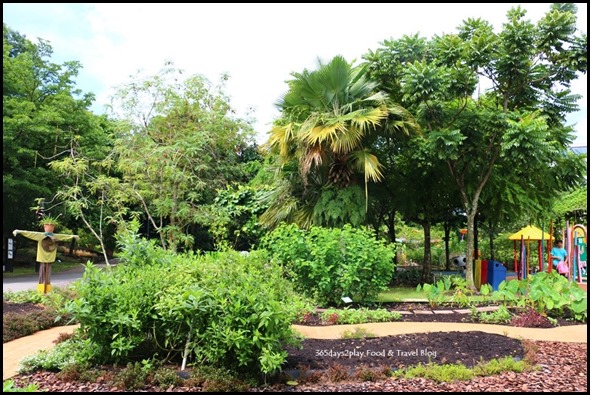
[{"xmin": 508, "ymin": 222, "xmax": 588, "ymax": 284}]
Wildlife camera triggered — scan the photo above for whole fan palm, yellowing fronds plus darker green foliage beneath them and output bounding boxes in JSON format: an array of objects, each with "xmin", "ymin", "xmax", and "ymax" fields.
[{"xmin": 262, "ymin": 56, "xmax": 418, "ymax": 226}]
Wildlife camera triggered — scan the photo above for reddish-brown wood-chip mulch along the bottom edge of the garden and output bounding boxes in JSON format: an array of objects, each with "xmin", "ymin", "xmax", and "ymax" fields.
[{"xmin": 9, "ymin": 342, "xmax": 588, "ymax": 392}]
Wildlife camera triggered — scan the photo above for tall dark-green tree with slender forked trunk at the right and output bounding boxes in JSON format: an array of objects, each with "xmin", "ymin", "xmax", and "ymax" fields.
[{"xmin": 367, "ymin": 4, "xmax": 587, "ymax": 284}]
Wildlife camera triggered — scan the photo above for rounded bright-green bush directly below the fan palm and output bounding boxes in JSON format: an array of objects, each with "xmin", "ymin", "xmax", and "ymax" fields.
[{"xmin": 262, "ymin": 225, "xmax": 395, "ymax": 306}]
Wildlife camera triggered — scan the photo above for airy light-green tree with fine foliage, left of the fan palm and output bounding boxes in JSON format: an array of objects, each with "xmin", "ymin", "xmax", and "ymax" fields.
[{"xmin": 113, "ymin": 65, "xmax": 253, "ymax": 250}]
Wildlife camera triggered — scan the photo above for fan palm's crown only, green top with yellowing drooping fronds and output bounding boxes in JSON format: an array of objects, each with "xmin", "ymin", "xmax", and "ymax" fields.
[{"xmin": 268, "ymin": 56, "xmax": 419, "ymax": 223}]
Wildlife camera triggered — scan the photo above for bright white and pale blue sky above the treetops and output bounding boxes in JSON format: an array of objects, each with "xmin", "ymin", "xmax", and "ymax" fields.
[{"xmin": 3, "ymin": 3, "xmax": 588, "ymax": 146}]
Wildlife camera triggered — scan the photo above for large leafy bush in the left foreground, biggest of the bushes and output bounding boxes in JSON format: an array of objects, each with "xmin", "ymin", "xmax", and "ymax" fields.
[{"xmin": 69, "ymin": 236, "xmax": 304, "ymax": 373}]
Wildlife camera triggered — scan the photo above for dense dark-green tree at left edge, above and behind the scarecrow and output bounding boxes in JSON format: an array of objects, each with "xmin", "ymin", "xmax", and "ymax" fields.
[{"xmin": 2, "ymin": 24, "xmax": 108, "ymax": 238}]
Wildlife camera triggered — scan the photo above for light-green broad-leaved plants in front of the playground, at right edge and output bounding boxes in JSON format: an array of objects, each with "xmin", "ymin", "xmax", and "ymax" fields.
[{"xmin": 493, "ymin": 271, "xmax": 588, "ymax": 322}]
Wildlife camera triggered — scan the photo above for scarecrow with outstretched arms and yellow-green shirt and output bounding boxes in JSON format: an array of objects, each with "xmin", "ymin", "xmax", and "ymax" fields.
[{"xmin": 12, "ymin": 225, "xmax": 79, "ymax": 293}]
